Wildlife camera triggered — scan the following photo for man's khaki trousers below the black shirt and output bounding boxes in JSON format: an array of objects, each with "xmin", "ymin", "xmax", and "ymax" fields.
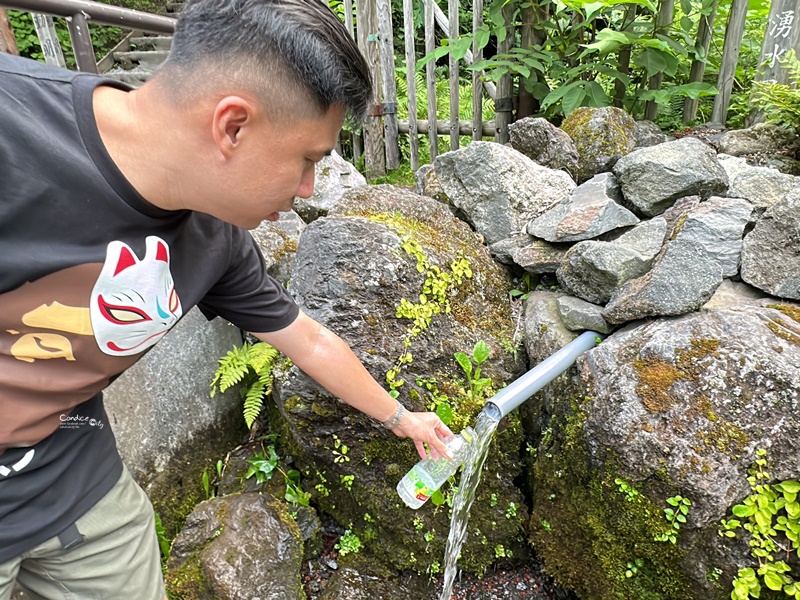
[{"xmin": 0, "ymin": 468, "xmax": 166, "ymax": 600}]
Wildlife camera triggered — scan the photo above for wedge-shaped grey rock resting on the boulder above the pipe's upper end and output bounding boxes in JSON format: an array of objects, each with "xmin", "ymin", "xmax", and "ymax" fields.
[{"xmin": 603, "ymin": 241, "xmax": 722, "ymax": 324}]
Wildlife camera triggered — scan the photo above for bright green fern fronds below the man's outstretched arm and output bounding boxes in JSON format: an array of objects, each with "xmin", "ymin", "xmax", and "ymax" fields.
[{"xmin": 211, "ymin": 342, "xmax": 280, "ymax": 429}]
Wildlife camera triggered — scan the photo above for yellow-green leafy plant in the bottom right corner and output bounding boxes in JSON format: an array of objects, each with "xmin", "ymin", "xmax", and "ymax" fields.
[{"xmin": 719, "ymin": 448, "xmax": 800, "ymax": 600}]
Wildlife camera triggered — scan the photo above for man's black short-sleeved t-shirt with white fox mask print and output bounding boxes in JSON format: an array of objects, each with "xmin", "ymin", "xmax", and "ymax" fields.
[{"xmin": 0, "ymin": 53, "xmax": 298, "ymax": 562}]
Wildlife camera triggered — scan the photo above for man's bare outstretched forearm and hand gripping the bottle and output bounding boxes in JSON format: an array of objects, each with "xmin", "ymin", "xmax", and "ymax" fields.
[{"xmin": 253, "ymin": 311, "xmax": 451, "ymax": 458}]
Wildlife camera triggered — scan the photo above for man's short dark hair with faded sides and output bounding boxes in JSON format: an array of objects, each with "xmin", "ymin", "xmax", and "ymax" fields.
[{"xmin": 158, "ymin": 0, "xmax": 372, "ymax": 121}]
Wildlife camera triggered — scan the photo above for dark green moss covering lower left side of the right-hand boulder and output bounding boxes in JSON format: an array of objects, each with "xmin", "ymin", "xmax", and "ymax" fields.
[{"xmin": 531, "ymin": 400, "xmax": 695, "ymax": 600}]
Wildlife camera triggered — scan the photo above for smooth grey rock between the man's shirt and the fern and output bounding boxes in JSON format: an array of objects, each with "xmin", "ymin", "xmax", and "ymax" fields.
[{"xmin": 103, "ymin": 308, "xmax": 244, "ymax": 492}]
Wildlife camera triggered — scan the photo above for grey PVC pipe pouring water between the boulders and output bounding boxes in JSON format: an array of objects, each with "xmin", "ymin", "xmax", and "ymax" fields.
[{"xmin": 483, "ymin": 331, "xmax": 605, "ymax": 421}]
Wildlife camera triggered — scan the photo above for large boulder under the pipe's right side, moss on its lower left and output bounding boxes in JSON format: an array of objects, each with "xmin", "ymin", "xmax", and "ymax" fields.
[{"xmin": 531, "ymin": 284, "xmax": 800, "ymax": 600}]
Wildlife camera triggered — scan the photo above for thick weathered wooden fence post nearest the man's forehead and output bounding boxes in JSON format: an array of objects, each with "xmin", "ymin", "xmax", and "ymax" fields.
[{"xmin": 356, "ymin": 0, "xmax": 386, "ymax": 179}]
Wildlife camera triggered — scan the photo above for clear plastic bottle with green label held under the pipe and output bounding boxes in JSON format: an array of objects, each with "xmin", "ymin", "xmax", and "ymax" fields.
[{"xmin": 397, "ymin": 427, "xmax": 475, "ymax": 509}]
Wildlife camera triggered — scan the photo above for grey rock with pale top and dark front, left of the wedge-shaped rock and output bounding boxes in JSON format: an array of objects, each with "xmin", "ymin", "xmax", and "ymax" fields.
[{"xmin": 556, "ymin": 217, "xmax": 667, "ymax": 304}]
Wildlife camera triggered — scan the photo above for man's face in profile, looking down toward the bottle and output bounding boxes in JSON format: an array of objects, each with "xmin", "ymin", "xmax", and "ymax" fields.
[{"xmin": 205, "ymin": 106, "xmax": 345, "ymax": 229}]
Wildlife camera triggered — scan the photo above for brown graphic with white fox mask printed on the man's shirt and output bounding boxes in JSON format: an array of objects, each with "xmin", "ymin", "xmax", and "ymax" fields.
[{"xmin": 0, "ymin": 236, "xmax": 183, "ymax": 453}]
